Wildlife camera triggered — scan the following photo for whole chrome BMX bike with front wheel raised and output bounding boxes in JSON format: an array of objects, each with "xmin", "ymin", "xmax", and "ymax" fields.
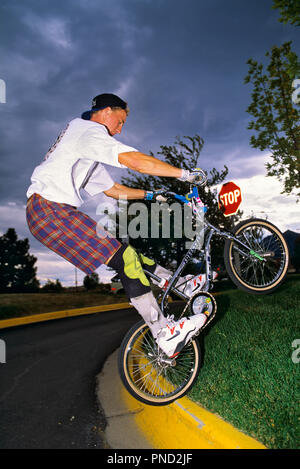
[{"xmin": 118, "ymin": 170, "xmax": 289, "ymax": 406}]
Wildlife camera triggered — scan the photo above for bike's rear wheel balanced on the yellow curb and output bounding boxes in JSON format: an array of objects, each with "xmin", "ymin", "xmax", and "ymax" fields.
[{"xmin": 119, "ymin": 321, "xmax": 201, "ymax": 406}]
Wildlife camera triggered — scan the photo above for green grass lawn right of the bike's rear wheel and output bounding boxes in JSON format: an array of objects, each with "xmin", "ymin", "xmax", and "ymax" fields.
[{"xmin": 189, "ymin": 275, "xmax": 300, "ymax": 449}]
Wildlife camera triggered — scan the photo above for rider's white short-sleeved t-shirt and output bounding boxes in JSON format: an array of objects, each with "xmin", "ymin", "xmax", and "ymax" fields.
[{"xmin": 27, "ymin": 118, "xmax": 138, "ymax": 207}]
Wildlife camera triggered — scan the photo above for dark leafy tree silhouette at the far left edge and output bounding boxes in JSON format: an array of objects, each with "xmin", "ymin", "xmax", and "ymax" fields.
[{"xmin": 0, "ymin": 228, "xmax": 39, "ymax": 292}]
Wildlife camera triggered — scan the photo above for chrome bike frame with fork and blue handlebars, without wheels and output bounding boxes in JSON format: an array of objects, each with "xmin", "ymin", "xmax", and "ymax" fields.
[{"xmin": 144, "ymin": 186, "xmax": 264, "ymax": 313}]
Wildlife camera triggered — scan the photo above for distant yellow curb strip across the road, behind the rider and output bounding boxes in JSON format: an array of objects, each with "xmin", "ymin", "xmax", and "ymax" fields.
[{"xmin": 0, "ymin": 303, "xmax": 133, "ymax": 329}]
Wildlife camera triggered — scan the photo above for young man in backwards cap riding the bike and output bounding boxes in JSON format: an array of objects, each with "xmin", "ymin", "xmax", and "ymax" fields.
[{"xmin": 27, "ymin": 94, "xmax": 207, "ymax": 357}]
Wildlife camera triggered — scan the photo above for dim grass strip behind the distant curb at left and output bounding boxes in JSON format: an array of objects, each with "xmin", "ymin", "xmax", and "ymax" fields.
[{"xmin": 0, "ymin": 291, "xmax": 128, "ymax": 320}]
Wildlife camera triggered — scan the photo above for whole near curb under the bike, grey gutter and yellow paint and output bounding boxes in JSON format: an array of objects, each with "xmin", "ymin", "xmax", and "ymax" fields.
[{"xmin": 97, "ymin": 351, "xmax": 267, "ymax": 449}]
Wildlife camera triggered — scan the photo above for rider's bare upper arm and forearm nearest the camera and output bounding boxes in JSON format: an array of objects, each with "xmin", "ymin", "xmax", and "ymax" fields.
[{"xmin": 119, "ymin": 151, "xmax": 182, "ymax": 178}]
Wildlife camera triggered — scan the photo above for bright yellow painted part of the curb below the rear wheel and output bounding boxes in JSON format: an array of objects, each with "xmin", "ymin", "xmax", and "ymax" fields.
[{"xmin": 121, "ymin": 387, "xmax": 267, "ymax": 449}]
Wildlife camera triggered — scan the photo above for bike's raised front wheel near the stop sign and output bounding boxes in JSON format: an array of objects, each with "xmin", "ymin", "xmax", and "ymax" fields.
[{"xmin": 224, "ymin": 218, "xmax": 289, "ymax": 294}]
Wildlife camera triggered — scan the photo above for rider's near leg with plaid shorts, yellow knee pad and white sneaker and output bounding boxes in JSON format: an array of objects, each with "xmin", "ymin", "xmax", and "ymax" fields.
[{"xmin": 26, "ymin": 194, "xmax": 204, "ymax": 356}]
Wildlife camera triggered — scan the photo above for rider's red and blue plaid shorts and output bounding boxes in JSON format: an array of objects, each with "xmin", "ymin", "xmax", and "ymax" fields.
[{"xmin": 26, "ymin": 194, "xmax": 121, "ymax": 275}]
